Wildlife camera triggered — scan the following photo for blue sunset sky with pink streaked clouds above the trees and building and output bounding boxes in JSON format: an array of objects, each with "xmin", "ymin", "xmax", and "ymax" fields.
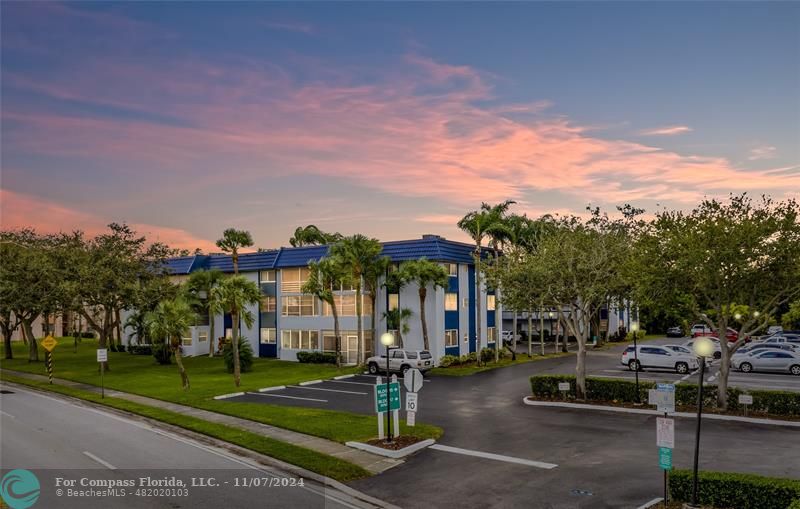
[{"xmin": 0, "ymin": 2, "xmax": 800, "ymax": 250}]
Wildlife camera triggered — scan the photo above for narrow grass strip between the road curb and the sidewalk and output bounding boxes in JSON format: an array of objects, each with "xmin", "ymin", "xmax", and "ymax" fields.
[{"xmin": 0, "ymin": 372, "xmax": 370, "ymax": 482}]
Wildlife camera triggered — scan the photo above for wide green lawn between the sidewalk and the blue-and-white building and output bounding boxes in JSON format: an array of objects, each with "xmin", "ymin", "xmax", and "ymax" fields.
[{"xmin": 0, "ymin": 338, "xmax": 442, "ymax": 443}]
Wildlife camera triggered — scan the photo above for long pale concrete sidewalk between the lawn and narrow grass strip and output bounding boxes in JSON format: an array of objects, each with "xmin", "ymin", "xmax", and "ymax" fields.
[{"xmin": 3, "ymin": 369, "xmax": 403, "ymax": 474}]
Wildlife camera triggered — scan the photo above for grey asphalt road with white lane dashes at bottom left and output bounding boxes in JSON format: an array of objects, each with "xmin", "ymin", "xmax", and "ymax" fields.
[{"xmin": 0, "ymin": 385, "xmax": 378, "ymax": 509}]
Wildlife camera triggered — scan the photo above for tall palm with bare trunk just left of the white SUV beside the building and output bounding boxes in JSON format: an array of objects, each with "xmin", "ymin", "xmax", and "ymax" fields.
[{"xmin": 330, "ymin": 234, "xmax": 383, "ymax": 364}]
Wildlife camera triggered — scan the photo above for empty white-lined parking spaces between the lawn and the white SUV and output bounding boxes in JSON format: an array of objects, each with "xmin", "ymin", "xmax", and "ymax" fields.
[{"xmin": 228, "ymin": 374, "xmax": 424, "ymax": 414}]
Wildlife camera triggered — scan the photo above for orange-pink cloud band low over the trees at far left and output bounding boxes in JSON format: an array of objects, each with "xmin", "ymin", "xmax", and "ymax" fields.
[{"xmin": 0, "ymin": 189, "xmax": 218, "ymax": 252}]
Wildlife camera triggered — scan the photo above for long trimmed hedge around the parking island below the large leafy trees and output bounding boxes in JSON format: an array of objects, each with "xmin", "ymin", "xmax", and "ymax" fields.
[{"xmin": 531, "ymin": 375, "xmax": 800, "ymax": 417}]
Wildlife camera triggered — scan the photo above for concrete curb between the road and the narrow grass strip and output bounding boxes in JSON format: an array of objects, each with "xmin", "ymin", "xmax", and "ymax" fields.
[{"xmin": 3, "ymin": 380, "xmax": 400, "ymax": 509}]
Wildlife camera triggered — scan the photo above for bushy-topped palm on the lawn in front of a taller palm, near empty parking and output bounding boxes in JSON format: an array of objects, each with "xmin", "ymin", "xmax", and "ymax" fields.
[{"xmin": 211, "ymin": 276, "xmax": 261, "ymax": 387}]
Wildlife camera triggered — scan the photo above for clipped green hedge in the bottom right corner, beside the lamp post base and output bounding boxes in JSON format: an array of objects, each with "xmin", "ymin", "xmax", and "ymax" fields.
[{"xmin": 669, "ymin": 470, "xmax": 800, "ymax": 509}]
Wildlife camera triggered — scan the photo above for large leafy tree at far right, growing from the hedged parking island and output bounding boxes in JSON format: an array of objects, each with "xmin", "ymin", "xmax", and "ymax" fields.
[{"xmin": 636, "ymin": 194, "xmax": 800, "ymax": 409}]
